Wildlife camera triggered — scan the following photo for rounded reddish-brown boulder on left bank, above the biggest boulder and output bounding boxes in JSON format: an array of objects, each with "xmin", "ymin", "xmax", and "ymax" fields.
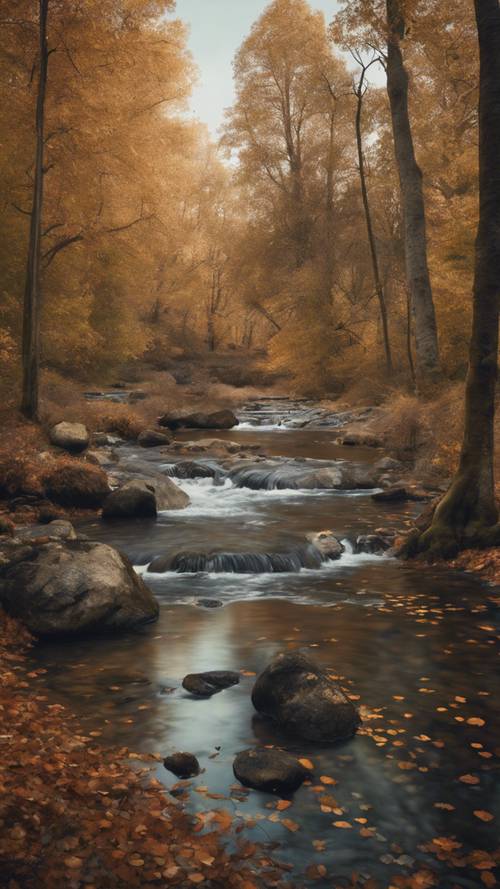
[{"xmin": 42, "ymin": 460, "xmax": 110, "ymax": 509}]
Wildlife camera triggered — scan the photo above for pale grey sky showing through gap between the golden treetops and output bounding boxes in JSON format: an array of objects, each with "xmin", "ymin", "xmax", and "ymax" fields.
[{"xmin": 171, "ymin": 0, "xmax": 338, "ymax": 136}]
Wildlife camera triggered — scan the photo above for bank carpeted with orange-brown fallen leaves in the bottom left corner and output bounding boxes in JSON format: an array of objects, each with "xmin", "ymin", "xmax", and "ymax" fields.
[{"xmin": 0, "ymin": 610, "xmax": 290, "ymax": 889}]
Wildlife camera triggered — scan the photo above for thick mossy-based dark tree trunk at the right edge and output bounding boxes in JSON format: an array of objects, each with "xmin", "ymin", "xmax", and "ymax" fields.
[{"xmin": 402, "ymin": 0, "xmax": 500, "ymax": 555}]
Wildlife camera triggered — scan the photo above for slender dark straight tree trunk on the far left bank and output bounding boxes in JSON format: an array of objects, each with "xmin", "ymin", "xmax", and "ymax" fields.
[{"xmin": 21, "ymin": 0, "xmax": 49, "ymax": 420}]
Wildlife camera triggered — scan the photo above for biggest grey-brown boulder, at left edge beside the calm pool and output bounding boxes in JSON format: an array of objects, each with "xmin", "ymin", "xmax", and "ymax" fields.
[{"xmin": 0, "ymin": 540, "xmax": 158, "ymax": 637}]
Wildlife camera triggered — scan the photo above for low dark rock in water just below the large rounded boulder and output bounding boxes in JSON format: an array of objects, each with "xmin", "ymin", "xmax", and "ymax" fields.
[{"xmin": 233, "ymin": 747, "xmax": 311, "ymax": 795}]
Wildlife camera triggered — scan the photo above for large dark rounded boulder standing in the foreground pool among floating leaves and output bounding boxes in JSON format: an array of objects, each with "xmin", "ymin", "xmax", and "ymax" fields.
[{"xmin": 252, "ymin": 652, "xmax": 361, "ymax": 742}]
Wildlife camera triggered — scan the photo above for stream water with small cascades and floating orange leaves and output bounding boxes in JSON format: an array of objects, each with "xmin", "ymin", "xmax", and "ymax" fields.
[{"xmin": 29, "ymin": 402, "xmax": 500, "ymax": 889}]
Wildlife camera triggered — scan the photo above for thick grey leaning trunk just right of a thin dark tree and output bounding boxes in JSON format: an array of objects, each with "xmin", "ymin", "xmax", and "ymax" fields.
[{"xmin": 386, "ymin": 0, "xmax": 439, "ymax": 380}]
